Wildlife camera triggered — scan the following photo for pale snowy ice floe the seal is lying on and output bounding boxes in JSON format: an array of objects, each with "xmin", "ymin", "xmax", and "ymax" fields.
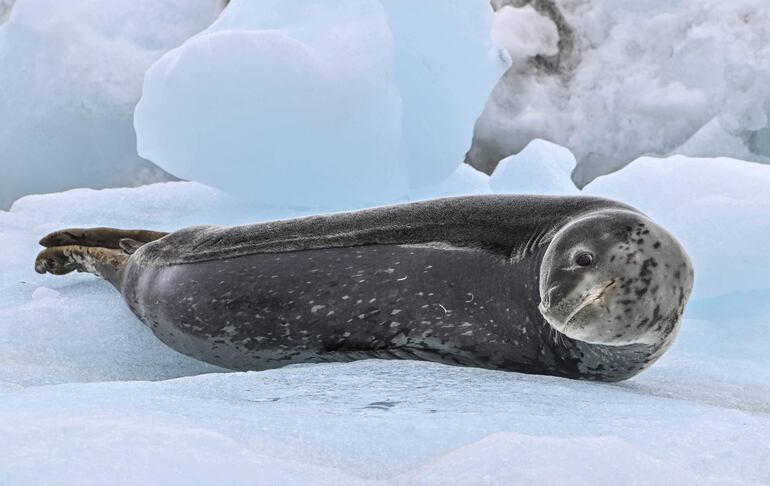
[{"xmin": 0, "ymin": 156, "xmax": 770, "ymax": 485}]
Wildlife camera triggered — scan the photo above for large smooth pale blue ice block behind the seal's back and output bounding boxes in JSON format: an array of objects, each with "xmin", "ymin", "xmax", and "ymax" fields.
[{"xmin": 134, "ymin": 0, "xmax": 504, "ymax": 208}]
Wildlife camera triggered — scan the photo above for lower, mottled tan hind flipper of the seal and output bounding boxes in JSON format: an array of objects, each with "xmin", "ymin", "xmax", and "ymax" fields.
[{"xmin": 35, "ymin": 245, "xmax": 128, "ymax": 285}]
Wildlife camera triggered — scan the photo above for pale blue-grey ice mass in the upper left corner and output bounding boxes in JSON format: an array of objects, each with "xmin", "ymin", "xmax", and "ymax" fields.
[{"xmin": 0, "ymin": 0, "xmax": 221, "ymax": 209}]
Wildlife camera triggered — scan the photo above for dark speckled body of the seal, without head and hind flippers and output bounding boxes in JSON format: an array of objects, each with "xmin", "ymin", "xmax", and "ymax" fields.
[{"xmin": 106, "ymin": 196, "xmax": 684, "ymax": 380}]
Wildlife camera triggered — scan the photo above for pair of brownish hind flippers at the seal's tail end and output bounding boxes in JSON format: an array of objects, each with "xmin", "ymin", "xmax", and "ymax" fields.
[{"xmin": 35, "ymin": 228, "xmax": 168, "ymax": 287}]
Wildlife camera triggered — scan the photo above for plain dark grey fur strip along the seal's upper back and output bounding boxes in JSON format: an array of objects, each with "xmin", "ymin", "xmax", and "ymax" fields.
[{"xmin": 132, "ymin": 195, "xmax": 641, "ymax": 266}]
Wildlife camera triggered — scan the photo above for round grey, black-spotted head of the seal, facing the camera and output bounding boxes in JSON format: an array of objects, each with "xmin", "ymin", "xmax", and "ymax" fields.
[{"xmin": 539, "ymin": 209, "xmax": 693, "ymax": 346}]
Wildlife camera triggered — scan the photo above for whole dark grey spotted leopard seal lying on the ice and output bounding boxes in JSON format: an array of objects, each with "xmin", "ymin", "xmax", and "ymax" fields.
[{"xmin": 35, "ymin": 195, "xmax": 693, "ymax": 381}]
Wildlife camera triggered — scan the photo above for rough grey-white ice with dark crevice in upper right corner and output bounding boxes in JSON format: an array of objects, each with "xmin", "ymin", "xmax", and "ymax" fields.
[{"xmin": 469, "ymin": 0, "xmax": 770, "ymax": 185}]
